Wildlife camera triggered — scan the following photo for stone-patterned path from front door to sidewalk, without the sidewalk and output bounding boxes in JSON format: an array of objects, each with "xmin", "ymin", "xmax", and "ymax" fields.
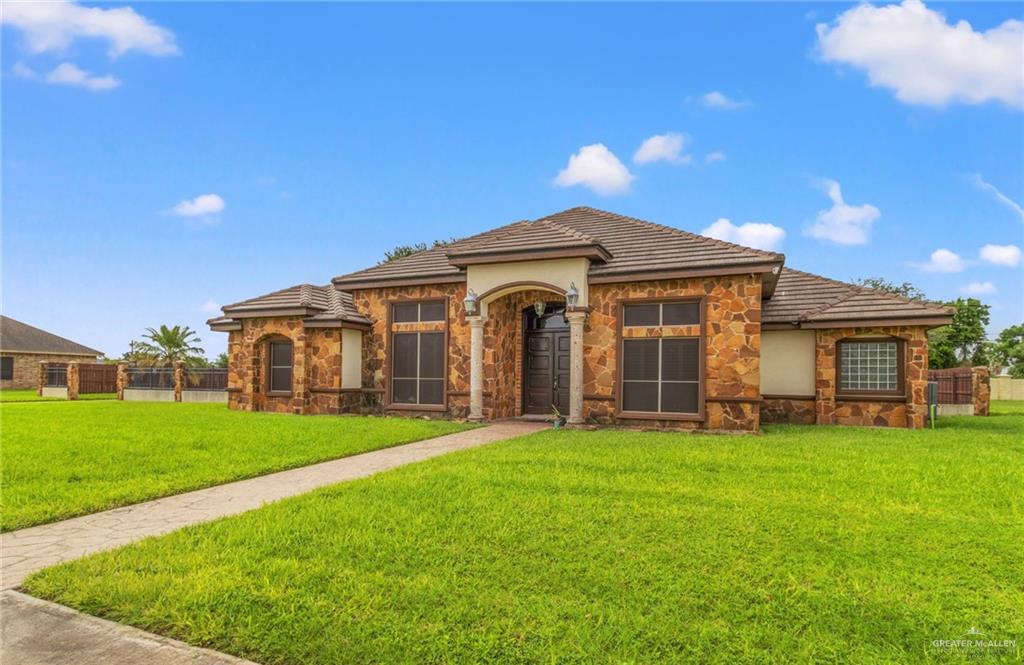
[{"xmin": 0, "ymin": 421, "xmax": 547, "ymax": 589}]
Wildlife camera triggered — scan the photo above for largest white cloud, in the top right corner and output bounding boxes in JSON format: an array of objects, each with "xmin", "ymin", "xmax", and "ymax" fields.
[{"xmin": 816, "ymin": 0, "xmax": 1024, "ymax": 107}]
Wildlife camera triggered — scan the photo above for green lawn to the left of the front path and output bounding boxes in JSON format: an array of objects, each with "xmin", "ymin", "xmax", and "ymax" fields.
[{"xmin": 0, "ymin": 401, "xmax": 467, "ymax": 531}]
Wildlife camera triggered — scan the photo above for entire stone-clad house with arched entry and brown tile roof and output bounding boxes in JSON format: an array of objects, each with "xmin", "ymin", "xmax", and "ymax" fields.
[{"xmin": 209, "ymin": 208, "xmax": 951, "ymax": 431}]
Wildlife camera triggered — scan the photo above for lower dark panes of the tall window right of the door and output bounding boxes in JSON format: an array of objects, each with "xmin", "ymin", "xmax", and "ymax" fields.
[{"xmin": 623, "ymin": 337, "xmax": 700, "ymax": 414}]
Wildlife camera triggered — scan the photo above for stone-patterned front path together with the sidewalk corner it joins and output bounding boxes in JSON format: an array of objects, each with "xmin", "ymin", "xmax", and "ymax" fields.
[{"xmin": 0, "ymin": 421, "xmax": 546, "ymax": 665}]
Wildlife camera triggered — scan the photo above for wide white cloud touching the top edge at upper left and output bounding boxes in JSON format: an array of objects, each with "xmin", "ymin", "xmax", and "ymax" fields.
[{"xmin": 0, "ymin": 1, "xmax": 178, "ymax": 57}]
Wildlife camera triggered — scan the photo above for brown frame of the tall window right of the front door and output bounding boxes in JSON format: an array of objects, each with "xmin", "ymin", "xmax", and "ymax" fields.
[{"xmin": 615, "ymin": 296, "xmax": 708, "ymax": 422}]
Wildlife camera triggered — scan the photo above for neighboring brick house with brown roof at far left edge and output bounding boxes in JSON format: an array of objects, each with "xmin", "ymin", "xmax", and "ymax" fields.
[{"xmin": 0, "ymin": 316, "xmax": 103, "ymax": 388}]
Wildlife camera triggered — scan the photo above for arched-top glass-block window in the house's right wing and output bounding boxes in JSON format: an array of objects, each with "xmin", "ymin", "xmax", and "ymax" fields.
[{"xmin": 837, "ymin": 339, "xmax": 903, "ymax": 394}]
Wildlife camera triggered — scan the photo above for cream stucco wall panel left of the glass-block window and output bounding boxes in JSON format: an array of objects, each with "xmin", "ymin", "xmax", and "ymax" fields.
[{"xmin": 761, "ymin": 330, "xmax": 815, "ymax": 398}]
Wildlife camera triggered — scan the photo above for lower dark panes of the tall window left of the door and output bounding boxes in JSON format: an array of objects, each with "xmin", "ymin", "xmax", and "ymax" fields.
[{"xmin": 391, "ymin": 332, "xmax": 444, "ymax": 405}]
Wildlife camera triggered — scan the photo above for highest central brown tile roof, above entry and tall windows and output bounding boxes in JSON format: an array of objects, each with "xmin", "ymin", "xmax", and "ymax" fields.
[{"xmin": 334, "ymin": 207, "xmax": 784, "ymax": 284}]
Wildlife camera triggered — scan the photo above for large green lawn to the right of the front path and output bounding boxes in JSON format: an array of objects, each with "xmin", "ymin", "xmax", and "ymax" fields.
[{"xmin": 27, "ymin": 404, "xmax": 1024, "ymax": 665}]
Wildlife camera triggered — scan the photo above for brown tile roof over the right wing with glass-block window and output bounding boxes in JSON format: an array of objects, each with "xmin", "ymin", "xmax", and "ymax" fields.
[{"xmin": 761, "ymin": 267, "xmax": 952, "ymax": 323}]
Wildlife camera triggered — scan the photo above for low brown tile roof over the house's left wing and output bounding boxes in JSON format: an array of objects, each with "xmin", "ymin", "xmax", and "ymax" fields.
[{"xmin": 216, "ymin": 284, "xmax": 370, "ymax": 326}]
